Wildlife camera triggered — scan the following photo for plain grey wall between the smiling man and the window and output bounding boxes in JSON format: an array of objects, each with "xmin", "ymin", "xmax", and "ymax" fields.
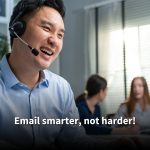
[{"xmin": 59, "ymin": 0, "xmax": 101, "ymax": 96}]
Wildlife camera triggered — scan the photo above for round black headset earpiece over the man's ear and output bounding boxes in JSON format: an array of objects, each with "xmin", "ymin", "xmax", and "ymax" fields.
[{"xmin": 9, "ymin": 21, "xmax": 26, "ymax": 38}]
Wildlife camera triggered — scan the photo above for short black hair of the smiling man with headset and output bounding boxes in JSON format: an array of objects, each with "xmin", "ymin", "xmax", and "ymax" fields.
[{"xmin": 9, "ymin": 0, "xmax": 65, "ymax": 46}]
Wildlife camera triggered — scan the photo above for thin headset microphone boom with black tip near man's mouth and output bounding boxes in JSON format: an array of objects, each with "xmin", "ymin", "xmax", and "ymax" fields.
[{"xmin": 9, "ymin": 27, "xmax": 39, "ymax": 56}]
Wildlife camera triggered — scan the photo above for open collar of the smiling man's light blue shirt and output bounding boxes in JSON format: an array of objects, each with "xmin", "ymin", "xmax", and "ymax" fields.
[{"xmin": 0, "ymin": 55, "xmax": 49, "ymax": 88}]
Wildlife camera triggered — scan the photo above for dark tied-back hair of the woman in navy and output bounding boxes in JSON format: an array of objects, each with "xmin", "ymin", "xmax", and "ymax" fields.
[{"xmin": 76, "ymin": 74, "xmax": 107, "ymax": 103}]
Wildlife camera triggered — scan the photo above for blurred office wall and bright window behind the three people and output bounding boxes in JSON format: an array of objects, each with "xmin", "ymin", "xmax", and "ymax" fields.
[{"xmin": 0, "ymin": 0, "xmax": 150, "ymax": 115}]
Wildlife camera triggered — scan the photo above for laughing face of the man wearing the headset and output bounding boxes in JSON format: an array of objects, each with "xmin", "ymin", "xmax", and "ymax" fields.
[{"xmin": 22, "ymin": 7, "xmax": 64, "ymax": 70}]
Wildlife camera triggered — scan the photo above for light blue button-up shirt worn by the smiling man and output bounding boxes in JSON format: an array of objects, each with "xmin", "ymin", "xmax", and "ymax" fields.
[{"xmin": 0, "ymin": 56, "xmax": 84, "ymax": 147}]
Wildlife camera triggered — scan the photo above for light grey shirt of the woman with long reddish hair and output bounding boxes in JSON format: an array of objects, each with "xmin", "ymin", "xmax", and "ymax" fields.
[{"xmin": 114, "ymin": 103, "xmax": 150, "ymax": 131}]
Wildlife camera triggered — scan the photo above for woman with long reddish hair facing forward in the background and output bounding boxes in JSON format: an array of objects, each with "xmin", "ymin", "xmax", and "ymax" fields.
[{"xmin": 115, "ymin": 77, "xmax": 150, "ymax": 131}]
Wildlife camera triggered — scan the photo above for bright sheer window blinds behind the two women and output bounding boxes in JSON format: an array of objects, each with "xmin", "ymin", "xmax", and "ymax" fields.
[{"xmin": 98, "ymin": 0, "xmax": 150, "ymax": 114}]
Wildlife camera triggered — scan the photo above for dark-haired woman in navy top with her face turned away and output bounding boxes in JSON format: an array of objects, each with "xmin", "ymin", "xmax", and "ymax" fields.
[{"xmin": 76, "ymin": 74, "xmax": 138, "ymax": 135}]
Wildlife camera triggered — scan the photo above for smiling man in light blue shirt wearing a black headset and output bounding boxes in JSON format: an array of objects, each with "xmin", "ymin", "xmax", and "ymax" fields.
[{"xmin": 0, "ymin": 0, "xmax": 138, "ymax": 149}]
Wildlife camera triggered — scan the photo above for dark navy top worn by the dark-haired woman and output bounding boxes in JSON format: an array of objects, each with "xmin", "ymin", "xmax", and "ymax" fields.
[{"xmin": 77, "ymin": 100, "xmax": 112, "ymax": 135}]
